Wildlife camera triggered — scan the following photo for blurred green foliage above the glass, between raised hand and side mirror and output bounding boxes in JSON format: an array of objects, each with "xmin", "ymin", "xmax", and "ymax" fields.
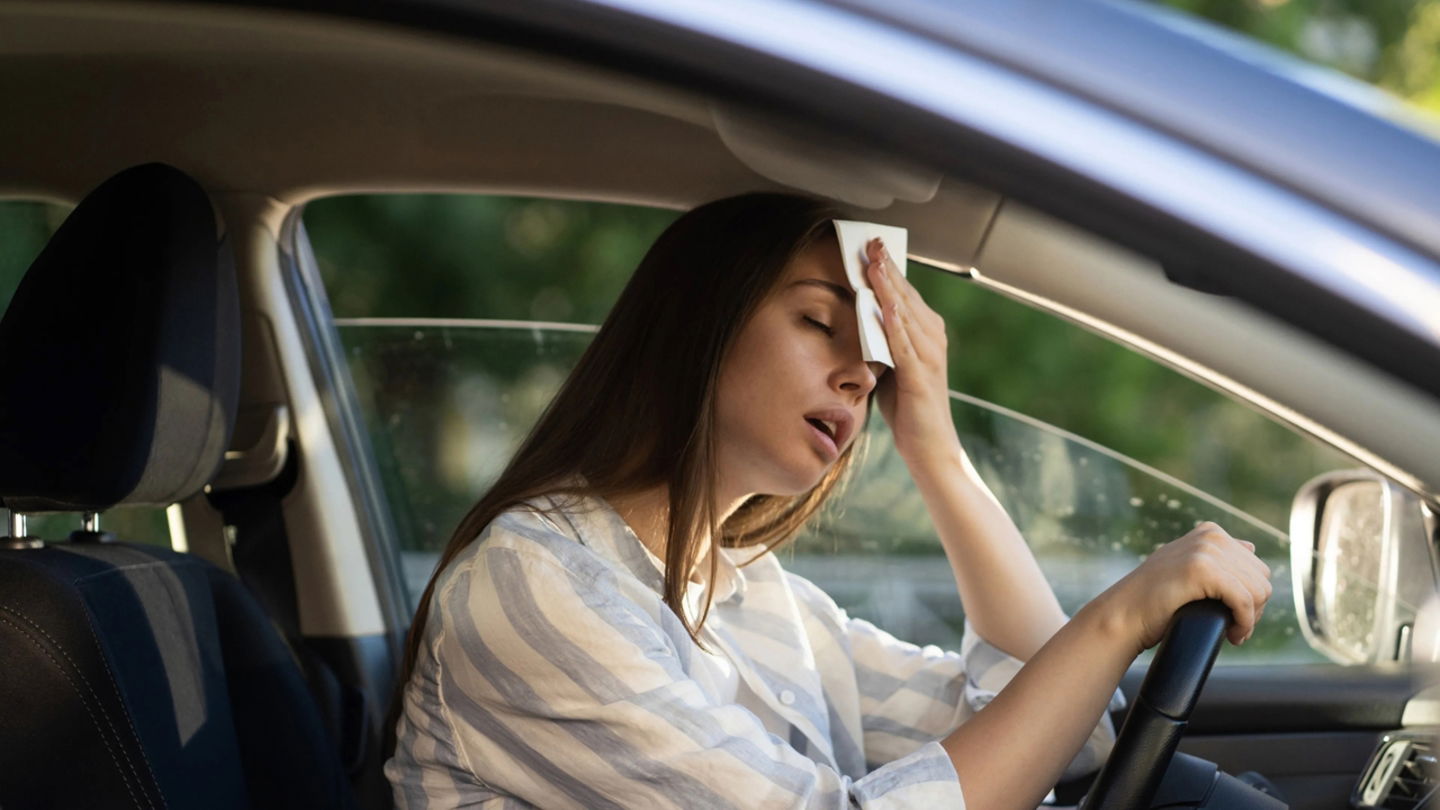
[{"xmin": 910, "ymin": 264, "xmax": 1356, "ymax": 529}]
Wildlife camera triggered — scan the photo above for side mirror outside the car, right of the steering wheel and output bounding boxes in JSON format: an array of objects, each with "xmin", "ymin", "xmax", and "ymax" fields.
[{"xmin": 1290, "ymin": 470, "xmax": 1440, "ymax": 664}]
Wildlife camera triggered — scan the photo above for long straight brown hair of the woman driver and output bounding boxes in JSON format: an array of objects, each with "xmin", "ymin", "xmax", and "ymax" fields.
[{"xmin": 392, "ymin": 193, "xmax": 854, "ymax": 686}]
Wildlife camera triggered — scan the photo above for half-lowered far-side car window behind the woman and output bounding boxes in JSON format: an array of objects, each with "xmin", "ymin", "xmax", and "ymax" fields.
[{"xmin": 304, "ymin": 195, "xmax": 1356, "ymax": 662}]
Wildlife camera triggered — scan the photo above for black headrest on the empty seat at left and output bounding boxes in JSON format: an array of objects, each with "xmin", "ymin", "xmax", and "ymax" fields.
[{"xmin": 0, "ymin": 163, "xmax": 240, "ymax": 512}]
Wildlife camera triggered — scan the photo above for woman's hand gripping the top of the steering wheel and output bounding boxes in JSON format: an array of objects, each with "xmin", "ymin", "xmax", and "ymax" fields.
[{"xmin": 1096, "ymin": 520, "xmax": 1272, "ymax": 654}]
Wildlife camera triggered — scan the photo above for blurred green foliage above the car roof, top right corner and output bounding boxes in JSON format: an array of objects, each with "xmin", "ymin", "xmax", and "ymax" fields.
[{"xmin": 1161, "ymin": 0, "xmax": 1440, "ymax": 114}]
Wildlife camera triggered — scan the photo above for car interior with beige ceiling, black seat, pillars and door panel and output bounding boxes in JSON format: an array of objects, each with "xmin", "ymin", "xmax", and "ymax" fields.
[{"xmin": 0, "ymin": 0, "xmax": 1440, "ymax": 809}]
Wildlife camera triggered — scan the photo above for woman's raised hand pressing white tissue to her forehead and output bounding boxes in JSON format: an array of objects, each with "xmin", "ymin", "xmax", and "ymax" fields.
[{"xmin": 865, "ymin": 239, "xmax": 960, "ymax": 468}]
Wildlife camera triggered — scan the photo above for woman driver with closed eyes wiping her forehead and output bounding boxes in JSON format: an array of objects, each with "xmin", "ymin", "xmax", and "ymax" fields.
[{"xmin": 386, "ymin": 195, "xmax": 1270, "ymax": 810}]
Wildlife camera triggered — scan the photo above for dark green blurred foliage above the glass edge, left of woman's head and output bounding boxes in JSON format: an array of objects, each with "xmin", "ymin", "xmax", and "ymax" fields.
[{"xmin": 305, "ymin": 195, "xmax": 675, "ymax": 323}]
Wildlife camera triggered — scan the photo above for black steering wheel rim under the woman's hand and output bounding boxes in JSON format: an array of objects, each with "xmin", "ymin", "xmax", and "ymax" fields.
[{"xmin": 1081, "ymin": 600, "xmax": 1230, "ymax": 810}]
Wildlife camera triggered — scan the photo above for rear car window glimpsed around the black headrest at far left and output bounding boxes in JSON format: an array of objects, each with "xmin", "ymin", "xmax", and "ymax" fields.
[{"xmin": 0, "ymin": 200, "xmax": 171, "ymax": 545}]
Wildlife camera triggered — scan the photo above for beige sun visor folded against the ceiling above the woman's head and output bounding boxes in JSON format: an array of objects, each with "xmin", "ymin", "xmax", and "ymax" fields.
[{"xmin": 710, "ymin": 105, "xmax": 940, "ymax": 209}]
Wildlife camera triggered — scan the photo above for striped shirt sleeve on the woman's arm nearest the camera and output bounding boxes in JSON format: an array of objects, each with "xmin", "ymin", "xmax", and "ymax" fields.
[{"xmin": 428, "ymin": 527, "xmax": 963, "ymax": 810}]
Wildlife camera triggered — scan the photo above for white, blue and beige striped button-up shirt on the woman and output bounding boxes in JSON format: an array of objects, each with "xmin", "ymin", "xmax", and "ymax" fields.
[{"xmin": 384, "ymin": 499, "xmax": 1119, "ymax": 810}]
